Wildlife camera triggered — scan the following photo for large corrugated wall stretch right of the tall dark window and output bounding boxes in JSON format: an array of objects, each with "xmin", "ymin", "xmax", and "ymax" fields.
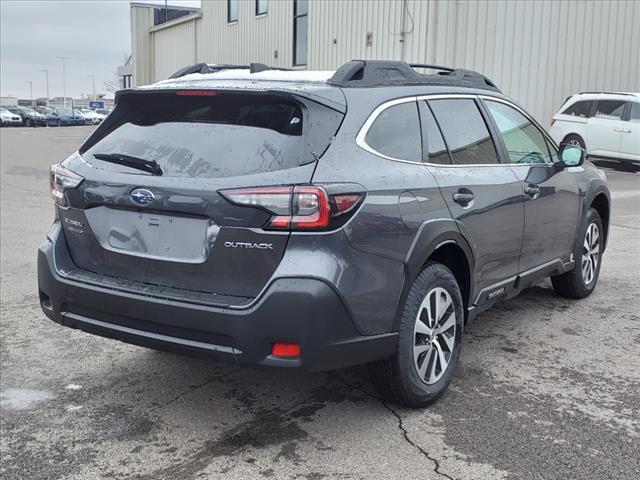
[{"xmin": 309, "ymin": 0, "xmax": 640, "ymax": 125}]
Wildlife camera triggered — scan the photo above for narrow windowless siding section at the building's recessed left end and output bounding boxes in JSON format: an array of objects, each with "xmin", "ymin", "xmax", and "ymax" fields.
[{"xmin": 152, "ymin": 19, "xmax": 198, "ymax": 81}]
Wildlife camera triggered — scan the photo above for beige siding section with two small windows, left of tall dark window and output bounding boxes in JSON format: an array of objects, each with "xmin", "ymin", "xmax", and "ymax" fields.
[{"xmin": 197, "ymin": 0, "xmax": 293, "ymax": 67}]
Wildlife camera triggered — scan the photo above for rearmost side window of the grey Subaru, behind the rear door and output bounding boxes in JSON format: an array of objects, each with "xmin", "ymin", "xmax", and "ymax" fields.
[{"xmin": 365, "ymin": 102, "xmax": 422, "ymax": 162}]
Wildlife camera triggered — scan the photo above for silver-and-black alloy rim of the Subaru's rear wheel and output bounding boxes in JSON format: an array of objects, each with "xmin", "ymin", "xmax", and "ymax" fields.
[{"xmin": 413, "ymin": 287, "xmax": 456, "ymax": 384}]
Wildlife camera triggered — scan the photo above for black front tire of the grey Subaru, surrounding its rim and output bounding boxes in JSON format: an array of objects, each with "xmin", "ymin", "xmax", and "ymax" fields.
[{"xmin": 551, "ymin": 208, "xmax": 604, "ymax": 298}]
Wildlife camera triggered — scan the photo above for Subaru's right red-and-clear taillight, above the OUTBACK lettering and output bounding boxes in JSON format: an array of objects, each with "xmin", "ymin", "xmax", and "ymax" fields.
[{"xmin": 220, "ymin": 186, "xmax": 363, "ymax": 230}]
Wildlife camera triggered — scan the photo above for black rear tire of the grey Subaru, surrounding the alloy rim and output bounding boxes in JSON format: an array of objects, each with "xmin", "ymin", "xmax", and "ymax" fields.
[{"xmin": 369, "ymin": 262, "xmax": 464, "ymax": 408}]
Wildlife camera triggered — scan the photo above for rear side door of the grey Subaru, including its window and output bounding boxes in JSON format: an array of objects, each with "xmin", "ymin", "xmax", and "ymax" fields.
[{"xmin": 423, "ymin": 96, "xmax": 523, "ymax": 296}]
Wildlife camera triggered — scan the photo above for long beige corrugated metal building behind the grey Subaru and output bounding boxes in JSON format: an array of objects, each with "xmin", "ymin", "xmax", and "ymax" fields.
[{"xmin": 131, "ymin": 0, "xmax": 640, "ymax": 125}]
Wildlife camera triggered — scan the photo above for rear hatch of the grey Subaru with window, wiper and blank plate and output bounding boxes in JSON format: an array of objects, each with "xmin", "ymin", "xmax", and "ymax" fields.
[{"xmin": 54, "ymin": 90, "xmax": 343, "ymax": 305}]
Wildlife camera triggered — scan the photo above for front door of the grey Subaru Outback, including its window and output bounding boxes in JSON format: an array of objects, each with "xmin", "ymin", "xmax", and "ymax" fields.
[{"xmin": 484, "ymin": 100, "xmax": 582, "ymax": 273}]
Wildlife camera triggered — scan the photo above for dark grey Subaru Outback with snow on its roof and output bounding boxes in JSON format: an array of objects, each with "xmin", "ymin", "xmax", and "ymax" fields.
[{"xmin": 38, "ymin": 61, "xmax": 610, "ymax": 407}]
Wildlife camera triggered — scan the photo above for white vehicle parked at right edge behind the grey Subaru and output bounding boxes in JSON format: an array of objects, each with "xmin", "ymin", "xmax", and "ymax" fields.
[{"xmin": 549, "ymin": 93, "xmax": 640, "ymax": 165}]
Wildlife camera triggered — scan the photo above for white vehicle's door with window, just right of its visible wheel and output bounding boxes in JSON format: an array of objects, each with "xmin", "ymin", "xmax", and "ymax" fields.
[{"xmin": 585, "ymin": 100, "xmax": 625, "ymax": 157}]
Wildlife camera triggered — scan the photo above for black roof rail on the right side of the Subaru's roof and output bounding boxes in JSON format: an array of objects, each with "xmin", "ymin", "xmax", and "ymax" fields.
[{"xmin": 327, "ymin": 60, "xmax": 500, "ymax": 91}]
